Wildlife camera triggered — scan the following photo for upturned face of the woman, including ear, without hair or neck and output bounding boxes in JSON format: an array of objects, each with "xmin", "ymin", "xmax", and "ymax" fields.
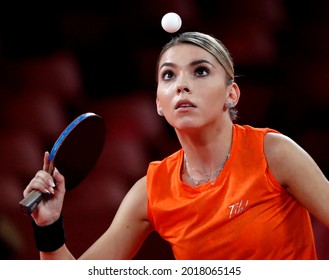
[{"xmin": 156, "ymin": 44, "xmax": 239, "ymax": 129}]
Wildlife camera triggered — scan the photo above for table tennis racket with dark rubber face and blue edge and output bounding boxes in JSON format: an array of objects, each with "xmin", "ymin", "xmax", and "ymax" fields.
[{"xmin": 19, "ymin": 113, "xmax": 105, "ymax": 214}]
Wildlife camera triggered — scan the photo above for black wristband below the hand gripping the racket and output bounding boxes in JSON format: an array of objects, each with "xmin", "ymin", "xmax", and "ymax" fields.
[{"xmin": 32, "ymin": 215, "xmax": 65, "ymax": 252}]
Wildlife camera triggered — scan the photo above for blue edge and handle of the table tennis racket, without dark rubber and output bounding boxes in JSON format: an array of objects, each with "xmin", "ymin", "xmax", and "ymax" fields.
[{"xmin": 19, "ymin": 113, "xmax": 105, "ymax": 214}]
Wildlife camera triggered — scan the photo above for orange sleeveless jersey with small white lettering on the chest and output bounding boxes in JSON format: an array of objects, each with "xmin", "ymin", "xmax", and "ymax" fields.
[{"xmin": 147, "ymin": 125, "xmax": 316, "ymax": 260}]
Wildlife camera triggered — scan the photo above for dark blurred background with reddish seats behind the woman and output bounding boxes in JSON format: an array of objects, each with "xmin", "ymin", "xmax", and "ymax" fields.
[{"xmin": 0, "ymin": 0, "xmax": 329, "ymax": 259}]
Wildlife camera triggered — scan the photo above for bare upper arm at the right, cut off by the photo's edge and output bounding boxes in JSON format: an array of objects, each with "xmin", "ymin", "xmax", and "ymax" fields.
[{"xmin": 264, "ymin": 133, "xmax": 329, "ymax": 227}]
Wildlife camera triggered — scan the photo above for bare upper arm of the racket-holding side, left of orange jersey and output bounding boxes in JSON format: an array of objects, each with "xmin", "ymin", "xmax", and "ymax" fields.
[{"xmin": 81, "ymin": 177, "xmax": 152, "ymax": 259}]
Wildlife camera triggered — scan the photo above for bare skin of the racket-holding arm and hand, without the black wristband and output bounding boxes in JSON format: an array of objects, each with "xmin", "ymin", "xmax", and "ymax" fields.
[{"xmin": 25, "ymin": 157, "xmax": 153, "ymax": 260}]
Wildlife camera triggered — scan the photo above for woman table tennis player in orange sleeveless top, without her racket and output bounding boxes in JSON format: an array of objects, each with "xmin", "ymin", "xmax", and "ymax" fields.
[{"xmin": 24, "ymin": 32, "xmax": 329, "ymax": 259}]
